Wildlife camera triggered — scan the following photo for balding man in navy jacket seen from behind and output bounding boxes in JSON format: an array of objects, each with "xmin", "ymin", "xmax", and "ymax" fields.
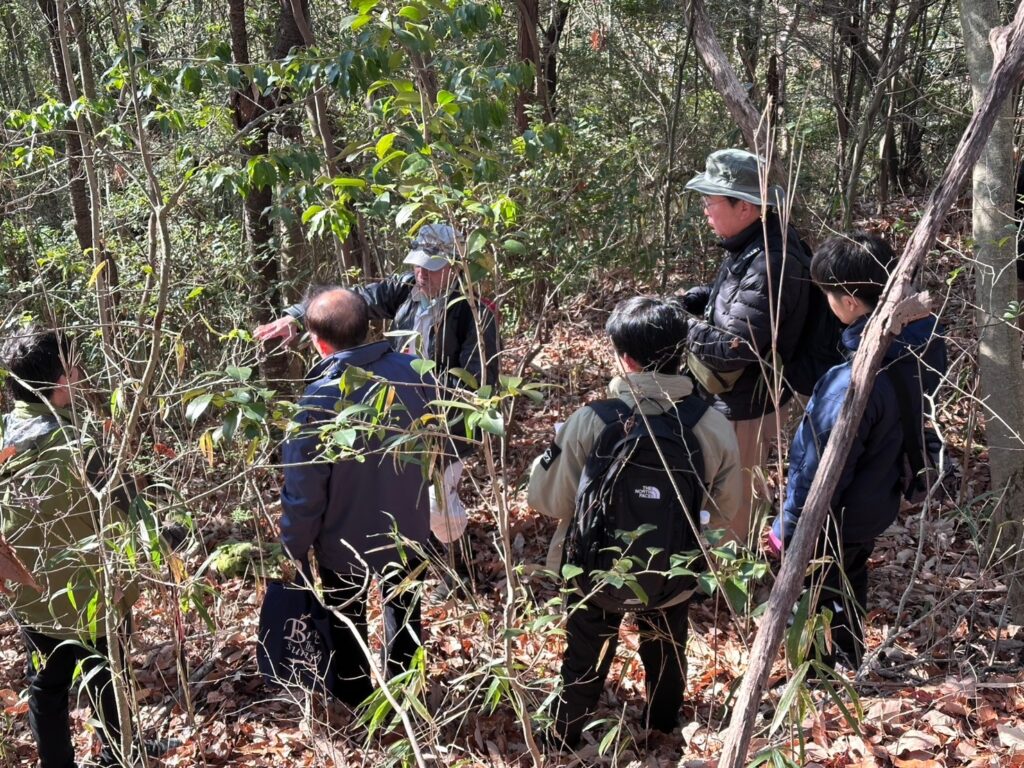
[{"xmin": 281, "ymin": 289, "xmax": 434, "ymax": 706}]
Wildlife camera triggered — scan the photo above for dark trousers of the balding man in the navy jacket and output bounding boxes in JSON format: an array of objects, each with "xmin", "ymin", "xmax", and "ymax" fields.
[{"xmin": 321, "ymin": 567, "xmax": 422, "ymax": 707}]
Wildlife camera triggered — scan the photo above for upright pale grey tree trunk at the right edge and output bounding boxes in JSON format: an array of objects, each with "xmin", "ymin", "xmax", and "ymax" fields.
[{"xmin": 959, "ymin": 0, "xmax": 1024, "ymax": 614}]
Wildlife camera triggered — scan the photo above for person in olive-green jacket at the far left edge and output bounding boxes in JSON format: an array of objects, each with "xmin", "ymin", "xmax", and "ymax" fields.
[{"xmin": 0, "ymin": 326, "xmax": 176, "ymax": 768}]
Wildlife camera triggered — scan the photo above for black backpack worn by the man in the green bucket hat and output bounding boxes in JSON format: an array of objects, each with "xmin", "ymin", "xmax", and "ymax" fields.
[{"xmin": 783, "ymin": 240, "xmax": 846, "ymax": 397}]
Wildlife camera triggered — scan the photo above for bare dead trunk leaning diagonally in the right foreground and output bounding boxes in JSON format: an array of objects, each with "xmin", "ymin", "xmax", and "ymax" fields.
[{"xmin": 718, "ymin": 3, "xmax": 1024, "ymax": 768}]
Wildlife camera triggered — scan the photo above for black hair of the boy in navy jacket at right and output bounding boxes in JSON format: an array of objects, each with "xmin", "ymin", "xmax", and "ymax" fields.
[{"xmin": 811, "ymin": 232, "xmax": 896, "ymax": 309}]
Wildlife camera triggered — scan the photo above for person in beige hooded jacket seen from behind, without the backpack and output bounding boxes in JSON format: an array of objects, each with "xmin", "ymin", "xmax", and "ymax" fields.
[{"xmin": 527, "ymin": 297, "xmax": 741, "ymax": 746}]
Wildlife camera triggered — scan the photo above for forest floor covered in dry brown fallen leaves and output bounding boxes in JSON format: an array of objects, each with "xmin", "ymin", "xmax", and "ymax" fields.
[{"xmin": 0, "ymin": 230, "xmax": 1024, "ymax": 768}]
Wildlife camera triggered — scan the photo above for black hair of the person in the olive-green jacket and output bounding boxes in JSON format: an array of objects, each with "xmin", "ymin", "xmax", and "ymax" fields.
[{"xmin": 0, "ymin": 325, "xmax": 72, "ymax": 402}]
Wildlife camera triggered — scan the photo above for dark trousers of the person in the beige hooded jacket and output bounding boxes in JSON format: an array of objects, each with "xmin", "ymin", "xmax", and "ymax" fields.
[{"xmin": 555, "ymin": 602, "xmax": 689, "ymax": 746}]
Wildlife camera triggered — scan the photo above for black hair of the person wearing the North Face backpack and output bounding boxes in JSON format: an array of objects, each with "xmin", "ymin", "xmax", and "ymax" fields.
[{"xmin": 604, "ymin": 296, "xmax": 688, "ymax": 374}]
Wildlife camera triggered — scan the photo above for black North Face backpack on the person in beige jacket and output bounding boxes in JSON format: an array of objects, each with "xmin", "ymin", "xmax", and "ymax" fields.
[{"xmin": 564, "ymin": 395, "xmax": 709, "ymax": 612}]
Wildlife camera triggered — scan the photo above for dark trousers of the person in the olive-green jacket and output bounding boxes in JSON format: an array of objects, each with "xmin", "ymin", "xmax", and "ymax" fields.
[{"xmin": 22, "ymin": 627, "xmax": 121, "ymax": 768}]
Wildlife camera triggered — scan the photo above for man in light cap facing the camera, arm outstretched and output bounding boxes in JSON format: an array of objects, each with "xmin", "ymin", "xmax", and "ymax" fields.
[{"xmin": 253, "ymin": 223, "xmax": 501, "ymax": 544}]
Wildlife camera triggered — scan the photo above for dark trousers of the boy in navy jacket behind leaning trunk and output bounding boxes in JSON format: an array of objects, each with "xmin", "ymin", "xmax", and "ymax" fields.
[{"xmin": 806, "ymin": 537, "xmax": 874, "ymax": 669}]
